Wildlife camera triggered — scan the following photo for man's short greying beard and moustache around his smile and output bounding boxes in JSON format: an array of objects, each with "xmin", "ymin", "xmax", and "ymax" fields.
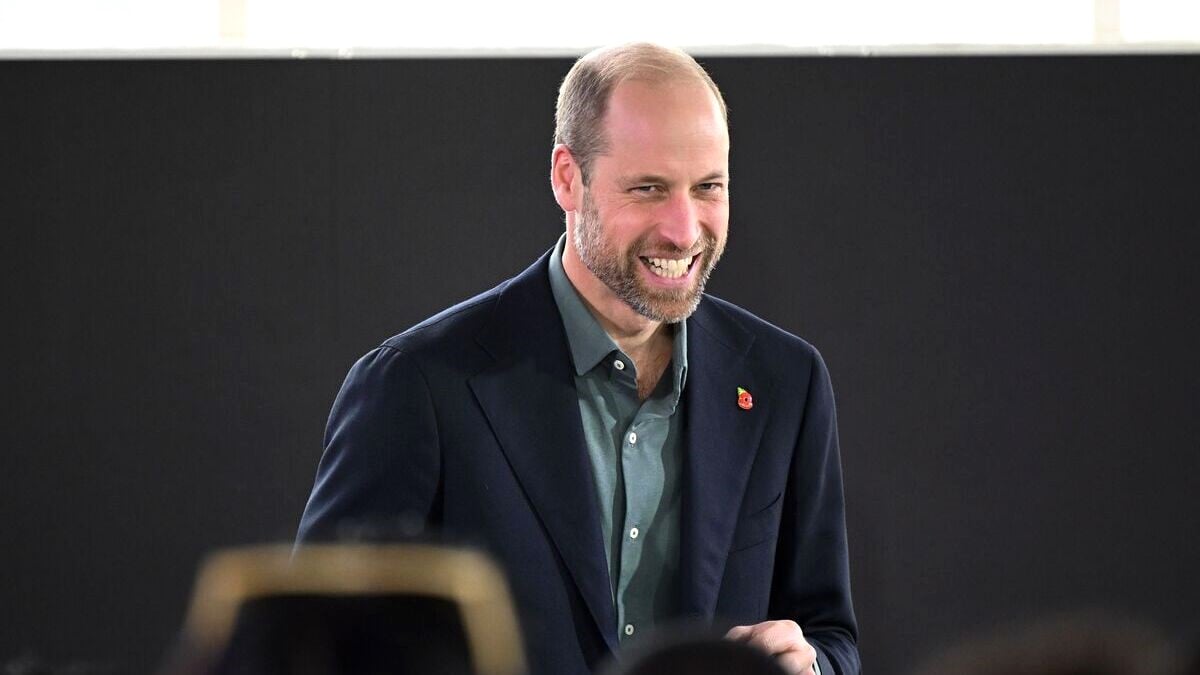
[{"xmin": 574, "ymin": 190, "xmax": 725, "ymax": 323}]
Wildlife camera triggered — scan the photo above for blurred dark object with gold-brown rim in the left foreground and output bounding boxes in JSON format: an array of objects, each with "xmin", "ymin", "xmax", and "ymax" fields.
[{"xmin": 164, "ymin": 544, "xmax": 524, "ymax": 675}]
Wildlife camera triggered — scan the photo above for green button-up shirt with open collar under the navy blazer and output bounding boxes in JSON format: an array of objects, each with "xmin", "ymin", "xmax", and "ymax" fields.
[{"xmin": 550, "ymin": 235, "xmax": 688, "ymax": 641}]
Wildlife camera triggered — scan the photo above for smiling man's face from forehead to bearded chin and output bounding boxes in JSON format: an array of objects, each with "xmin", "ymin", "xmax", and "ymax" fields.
[{"xmin": 572, "ymin": 80, "xmax": 730, "ymax": 323}]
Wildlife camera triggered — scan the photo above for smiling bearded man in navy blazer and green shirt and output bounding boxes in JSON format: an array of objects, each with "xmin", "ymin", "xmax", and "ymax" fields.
[{"xmin": 299, "ymin": 44, "xmax": 859, "ymax": 675}]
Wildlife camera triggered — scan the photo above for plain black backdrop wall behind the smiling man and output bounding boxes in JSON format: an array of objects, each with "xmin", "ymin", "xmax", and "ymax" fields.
[{"xmin": 0, "ymin": 55, "xmax": 1200, "ymax": 673}]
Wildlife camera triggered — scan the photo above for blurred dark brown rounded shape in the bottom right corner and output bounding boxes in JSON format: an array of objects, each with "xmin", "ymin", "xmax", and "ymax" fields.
[{"xmin": 916, "ymin": 613, "xmax": 1174, "ymax": 675}]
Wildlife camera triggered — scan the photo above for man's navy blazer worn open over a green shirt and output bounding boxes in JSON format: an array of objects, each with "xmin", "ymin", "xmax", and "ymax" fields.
[{"xmin": 298, "ymin": 248, "xmax": 859, "ymax": 675}]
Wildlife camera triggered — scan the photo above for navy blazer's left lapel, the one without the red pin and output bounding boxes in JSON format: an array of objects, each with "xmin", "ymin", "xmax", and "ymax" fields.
[{"xmin": 469, "ymin": 253, "xmax": 617, "ymax": 650}]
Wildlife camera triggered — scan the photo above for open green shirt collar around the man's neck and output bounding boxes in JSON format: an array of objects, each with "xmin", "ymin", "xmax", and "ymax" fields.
[{"xmin": 550, "ymin": 234, "xmax": 688, "ymax": 398}]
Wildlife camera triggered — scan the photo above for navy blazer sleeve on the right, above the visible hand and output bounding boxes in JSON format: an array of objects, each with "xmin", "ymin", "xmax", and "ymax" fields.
[{"xmin": 769, "ymin": 352, "xmax": 862, "ymax": 675}]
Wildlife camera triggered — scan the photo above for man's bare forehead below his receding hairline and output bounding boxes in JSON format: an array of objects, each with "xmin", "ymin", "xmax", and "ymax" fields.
[{"xmin": 604, "ymin": 79, "xmax": 730, "ymax": 173}]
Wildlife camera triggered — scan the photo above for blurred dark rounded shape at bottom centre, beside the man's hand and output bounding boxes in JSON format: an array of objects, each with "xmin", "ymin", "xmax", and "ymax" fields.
[{"xmin": 602, "ymin": 628, "xmax": 787, "ymax": 675}]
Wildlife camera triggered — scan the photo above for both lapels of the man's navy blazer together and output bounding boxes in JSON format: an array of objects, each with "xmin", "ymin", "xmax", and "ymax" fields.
[{"xmin": 469, "ymin": 251, "xmax": 772, "ymax": 634}]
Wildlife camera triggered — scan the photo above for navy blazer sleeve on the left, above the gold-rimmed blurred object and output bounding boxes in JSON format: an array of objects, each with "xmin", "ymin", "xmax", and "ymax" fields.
[{"xmin": 296, "ymin": 346, "xmax": 442, "ymax": 544}]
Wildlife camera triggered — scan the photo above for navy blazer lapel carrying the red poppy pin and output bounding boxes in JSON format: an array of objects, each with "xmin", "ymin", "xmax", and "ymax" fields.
[{"xmin": 679, "ymin": 298, "xmax": 770, "ymax": 619}]
